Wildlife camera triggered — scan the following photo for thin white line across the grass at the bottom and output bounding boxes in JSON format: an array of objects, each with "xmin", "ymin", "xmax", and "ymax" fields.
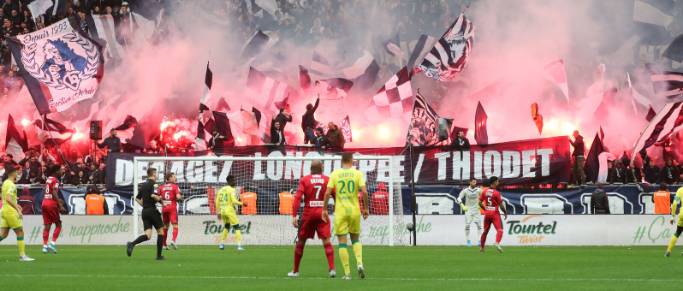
[{"xmin": 0, "ymin": 274, "xmax": 683, "ymax": 282}]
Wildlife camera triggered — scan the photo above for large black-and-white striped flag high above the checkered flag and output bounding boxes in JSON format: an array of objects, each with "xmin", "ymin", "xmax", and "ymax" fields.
[{"xmin": 415, "ymin": 13, "xmax": 474, "ymax": 82}]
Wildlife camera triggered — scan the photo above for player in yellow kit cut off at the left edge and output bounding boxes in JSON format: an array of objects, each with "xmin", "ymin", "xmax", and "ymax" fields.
[{"xmin": 0, "ymin": 167, "xmax": 35, "ymax": 262}]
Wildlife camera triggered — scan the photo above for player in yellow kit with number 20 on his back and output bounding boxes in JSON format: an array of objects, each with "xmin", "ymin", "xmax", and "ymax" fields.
[{"xmin": 322, "ymin": 152, "xmax": 370, "ymax": 280}]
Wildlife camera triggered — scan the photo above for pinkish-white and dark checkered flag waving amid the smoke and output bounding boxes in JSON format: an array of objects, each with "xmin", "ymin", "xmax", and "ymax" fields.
[{"xmin": 365, "ymin": 67, "xmax": 413, "ymax": 122}]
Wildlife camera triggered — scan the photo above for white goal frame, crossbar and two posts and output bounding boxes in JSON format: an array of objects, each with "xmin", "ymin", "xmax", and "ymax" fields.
[{"xmin": 133, "ymin": 155, "xmax": 396, "ymax": 246}]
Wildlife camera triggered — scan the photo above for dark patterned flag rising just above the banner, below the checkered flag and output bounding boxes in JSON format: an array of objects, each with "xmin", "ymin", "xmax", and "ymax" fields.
[{"xmin": 408, "ymin": 92, "xmax": 439, "ymax": 146}]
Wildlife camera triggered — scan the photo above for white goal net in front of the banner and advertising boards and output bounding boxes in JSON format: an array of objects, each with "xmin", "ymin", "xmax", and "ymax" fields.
[{"xmin": 133, "ymin": 155, "xmax": 408, "ymax": 246}]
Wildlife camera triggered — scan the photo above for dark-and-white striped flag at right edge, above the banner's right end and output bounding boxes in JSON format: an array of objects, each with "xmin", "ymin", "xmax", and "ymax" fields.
[{"xmin": 632, "ymin": 101, "xmax": 683, "ymax": 153}]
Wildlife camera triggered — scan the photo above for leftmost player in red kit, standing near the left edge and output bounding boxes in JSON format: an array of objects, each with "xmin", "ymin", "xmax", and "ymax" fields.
[{"xmin": 40, "ymin": 165, "xmax": 66, "ymax": 254}]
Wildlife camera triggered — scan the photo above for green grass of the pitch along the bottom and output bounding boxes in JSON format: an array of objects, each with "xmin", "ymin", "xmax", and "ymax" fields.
[{"xmin": 0, "ymin": 244, "xmax": 683, "ymax": 291}]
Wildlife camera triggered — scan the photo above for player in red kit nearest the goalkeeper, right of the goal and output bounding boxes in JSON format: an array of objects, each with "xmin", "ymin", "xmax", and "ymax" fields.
[{"xmin": 479, "ymin": 176, "xmax": 508, "ymax": 253}]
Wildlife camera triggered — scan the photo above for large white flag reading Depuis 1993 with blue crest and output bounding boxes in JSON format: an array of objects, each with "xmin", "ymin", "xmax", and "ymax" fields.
[{"xmin": 8, "ymin": 18, "xmax": 104, "ymax": 115}]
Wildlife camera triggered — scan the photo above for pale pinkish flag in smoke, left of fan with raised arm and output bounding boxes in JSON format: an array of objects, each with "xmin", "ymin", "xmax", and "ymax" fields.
[{"xmin": 247, "ymin": 68, "xmax": 299, "ymax": 114}]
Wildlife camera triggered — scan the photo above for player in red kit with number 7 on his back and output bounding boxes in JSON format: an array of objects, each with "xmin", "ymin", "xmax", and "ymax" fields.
[{"xmin": 287, "ymin": 160, "xmax": 337, "ymax": 278}]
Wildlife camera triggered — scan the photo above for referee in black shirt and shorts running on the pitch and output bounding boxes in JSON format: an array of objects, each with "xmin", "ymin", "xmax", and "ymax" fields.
[{"xmin": 126, "ymin": 168, "xmax": 166, "ymax": 261}]
